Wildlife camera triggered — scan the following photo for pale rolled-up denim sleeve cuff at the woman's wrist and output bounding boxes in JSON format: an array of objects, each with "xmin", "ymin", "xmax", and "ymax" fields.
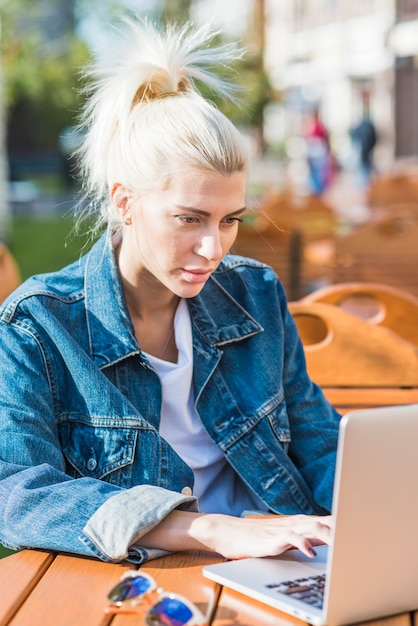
[{"xmin": 80, "ymin": 485, "xmax": 198, "ymax": 564}]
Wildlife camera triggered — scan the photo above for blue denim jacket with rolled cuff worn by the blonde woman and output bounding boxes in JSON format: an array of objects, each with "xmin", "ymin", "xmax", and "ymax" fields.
[{"xmin": 0, "ymin": 230, "xmax": 339, "ymax": 563}]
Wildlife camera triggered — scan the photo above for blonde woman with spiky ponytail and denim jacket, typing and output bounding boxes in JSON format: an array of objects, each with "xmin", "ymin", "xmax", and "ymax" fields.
[{"xmin": 0, "ymin": 21, "xmax": 339, "ymax": 563}]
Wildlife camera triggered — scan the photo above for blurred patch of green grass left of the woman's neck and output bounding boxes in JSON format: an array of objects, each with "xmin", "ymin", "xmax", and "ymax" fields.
[{"xmin": 9, "ymin": 216, "xmax": 95, "ymax": 280}]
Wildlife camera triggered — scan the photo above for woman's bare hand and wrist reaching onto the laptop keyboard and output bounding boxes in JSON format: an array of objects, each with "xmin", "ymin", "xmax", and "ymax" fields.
[{"xmin": 140, "ymin": 510, "xmax": 332, "ymax": 559}]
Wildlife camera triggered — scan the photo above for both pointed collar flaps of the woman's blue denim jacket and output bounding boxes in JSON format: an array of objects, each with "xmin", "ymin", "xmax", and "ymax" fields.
[{"xmin": 85, "ymin": 233, "xmax": 263, "ymax": 367}]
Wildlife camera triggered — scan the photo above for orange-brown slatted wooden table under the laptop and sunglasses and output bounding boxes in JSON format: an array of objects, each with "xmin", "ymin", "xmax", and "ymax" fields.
[{"xmin": 0, "ymin": 550, "xmax": 418, "ymax": 626}]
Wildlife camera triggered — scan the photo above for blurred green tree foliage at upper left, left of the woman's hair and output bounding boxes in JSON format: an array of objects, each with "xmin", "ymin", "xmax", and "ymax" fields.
[{"xmin": 0, "ymin": 0, "xmax": 89, "ymax": 239}]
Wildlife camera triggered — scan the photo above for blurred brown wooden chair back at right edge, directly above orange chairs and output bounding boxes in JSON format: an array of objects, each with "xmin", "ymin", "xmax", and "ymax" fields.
[{"xmin": 331, "ymin": 215, "xmax": 418, "ymax": 296}]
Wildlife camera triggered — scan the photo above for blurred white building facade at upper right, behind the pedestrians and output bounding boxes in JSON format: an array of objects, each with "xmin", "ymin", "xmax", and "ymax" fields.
[{"xmin": 264, "ymin": 0, "xmax": 418, "ymax": 170}]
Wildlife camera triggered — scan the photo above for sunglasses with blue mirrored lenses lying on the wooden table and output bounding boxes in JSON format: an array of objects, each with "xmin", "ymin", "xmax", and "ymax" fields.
[{"xmin": 105, "ymin": 570, "xmax": 208, "ymax": 626}]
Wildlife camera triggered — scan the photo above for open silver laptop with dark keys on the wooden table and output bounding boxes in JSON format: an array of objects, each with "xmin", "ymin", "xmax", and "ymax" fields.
[{"xmin": 203, "ymin": 404, "xmax": 418, "ymax": 626}]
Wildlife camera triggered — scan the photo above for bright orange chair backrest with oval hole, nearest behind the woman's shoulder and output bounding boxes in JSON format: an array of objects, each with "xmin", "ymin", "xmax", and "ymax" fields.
[{"xmin": 289, "ymin": 302, "xmax": 418, "ymax": 387}]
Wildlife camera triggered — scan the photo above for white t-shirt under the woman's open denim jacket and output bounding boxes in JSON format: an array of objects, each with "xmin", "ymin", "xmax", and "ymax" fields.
[{"xmin": 147, "ymin": 299, "xmax": 267, "ymax": 515}]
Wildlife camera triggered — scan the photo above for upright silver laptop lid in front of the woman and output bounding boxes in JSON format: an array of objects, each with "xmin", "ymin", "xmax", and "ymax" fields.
[{"xmin": 324, "ymin": 405, "xmax": 418, "ymax": 624}]
